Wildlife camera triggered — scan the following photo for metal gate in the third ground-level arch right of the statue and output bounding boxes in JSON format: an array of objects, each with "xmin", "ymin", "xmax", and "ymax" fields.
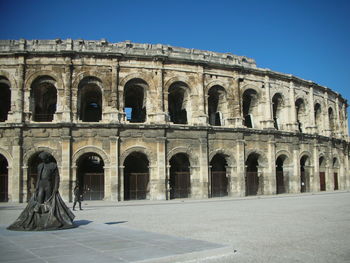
[{"xmin": 170, "ymin": 172, "xmax": 191, "ymax": 199}]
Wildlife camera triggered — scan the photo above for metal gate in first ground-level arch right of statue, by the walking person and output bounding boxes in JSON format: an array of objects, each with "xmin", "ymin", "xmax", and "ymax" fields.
[{"xmin": 83, "ymin": 173, "xmax": 104, "ymax": 200}]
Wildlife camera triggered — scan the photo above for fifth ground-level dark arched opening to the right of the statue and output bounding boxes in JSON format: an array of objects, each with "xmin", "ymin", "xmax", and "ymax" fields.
[{"xmin": 245, "ymin": 153, "xmax": 262, "ymax": 196}]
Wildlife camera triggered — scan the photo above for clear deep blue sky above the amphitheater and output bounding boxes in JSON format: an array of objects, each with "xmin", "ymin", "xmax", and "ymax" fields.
[{"xmin": 0, "ymin": 0, "xmax": 350, "ymax": 106}]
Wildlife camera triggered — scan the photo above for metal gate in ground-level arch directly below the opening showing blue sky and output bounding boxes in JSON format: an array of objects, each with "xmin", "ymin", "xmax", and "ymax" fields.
[{"xmin": 124, "ymin": 173, "xmax": 149, "ymax": 200}]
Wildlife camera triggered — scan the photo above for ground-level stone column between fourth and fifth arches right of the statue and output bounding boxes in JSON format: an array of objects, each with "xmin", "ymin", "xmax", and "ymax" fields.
[{"xmin": 232, "ymin": 138, "xmax": 246, "ymax": 196}]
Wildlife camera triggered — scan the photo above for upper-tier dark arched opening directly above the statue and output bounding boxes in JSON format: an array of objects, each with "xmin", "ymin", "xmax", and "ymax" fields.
[{"xmin": 30, "ymin": 76, "xmax": 57, "ymax": 122}]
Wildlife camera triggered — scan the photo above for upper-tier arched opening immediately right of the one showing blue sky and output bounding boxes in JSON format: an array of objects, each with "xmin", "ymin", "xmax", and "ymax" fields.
[{"xmin": 168, "ymin": 81, "xmax": 190, "ymax": 124}]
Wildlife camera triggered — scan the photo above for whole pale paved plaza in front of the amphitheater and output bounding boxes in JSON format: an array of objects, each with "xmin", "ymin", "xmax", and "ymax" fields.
[{"xmin": 0, "ymin": 192, "xmax": 350, "ymax": 263}]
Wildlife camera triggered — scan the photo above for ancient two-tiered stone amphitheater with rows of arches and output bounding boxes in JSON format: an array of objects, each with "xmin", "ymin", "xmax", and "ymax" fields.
[{"xmin": 0, "ymin": 39, "xmax": 350, "ymax": 202}]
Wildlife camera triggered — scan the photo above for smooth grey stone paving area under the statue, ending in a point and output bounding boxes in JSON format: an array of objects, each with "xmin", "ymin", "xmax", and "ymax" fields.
[{"xmin": 0, "ymin": 221, "xmax": 226, "ymax": 263}]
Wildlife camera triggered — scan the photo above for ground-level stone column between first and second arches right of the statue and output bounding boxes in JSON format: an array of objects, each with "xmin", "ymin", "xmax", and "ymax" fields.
[{"xmin": 106, "ymin": 136, "xmax": 119, "ymax": 201}]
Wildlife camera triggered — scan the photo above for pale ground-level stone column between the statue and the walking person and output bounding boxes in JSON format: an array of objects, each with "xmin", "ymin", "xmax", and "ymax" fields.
[{"xmin": 59, "ymin": 133, "xmax": 71, "ymax": 201}]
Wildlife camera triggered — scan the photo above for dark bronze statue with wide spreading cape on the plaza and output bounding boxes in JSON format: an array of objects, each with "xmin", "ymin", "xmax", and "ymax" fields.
[{"xmin": 7, "ymin": 152, "xmax": 74, "ymax": 231}]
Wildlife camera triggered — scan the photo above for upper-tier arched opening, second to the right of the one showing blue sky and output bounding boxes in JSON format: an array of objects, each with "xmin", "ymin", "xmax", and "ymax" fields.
[{"xmin": 208, "ymin": 85, "xmax": 226, "ymax": 126}]
